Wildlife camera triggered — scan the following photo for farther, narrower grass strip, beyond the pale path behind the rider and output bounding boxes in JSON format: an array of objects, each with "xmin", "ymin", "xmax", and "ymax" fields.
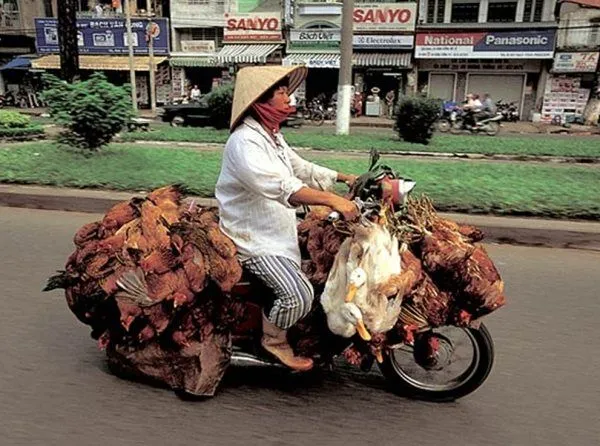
[{"xmin": 122, "ymin": 125, "xmax": 600, "ymax": 158}]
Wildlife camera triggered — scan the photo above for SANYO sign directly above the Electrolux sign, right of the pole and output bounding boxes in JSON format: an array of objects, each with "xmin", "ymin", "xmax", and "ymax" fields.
[{"xmin": 353, "ymin": 3, "xmax": 416, "ymax": 31}]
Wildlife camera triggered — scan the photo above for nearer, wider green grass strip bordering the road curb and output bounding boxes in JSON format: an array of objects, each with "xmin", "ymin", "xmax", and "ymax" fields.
[{"xmin": 0, "ymin": 142, "xmax": 600, "ymax": 219}]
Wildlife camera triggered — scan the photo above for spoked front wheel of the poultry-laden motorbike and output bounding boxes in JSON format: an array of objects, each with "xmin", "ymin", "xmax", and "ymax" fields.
[{"xmin": 379, "ymin": 324, "xmax": 494, "ymax": 402}]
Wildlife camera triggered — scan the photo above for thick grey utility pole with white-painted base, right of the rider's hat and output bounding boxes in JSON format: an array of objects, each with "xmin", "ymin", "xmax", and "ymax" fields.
[{"xmin": 336, "ymin": 0, "xmax": 354, "ymax": 135}]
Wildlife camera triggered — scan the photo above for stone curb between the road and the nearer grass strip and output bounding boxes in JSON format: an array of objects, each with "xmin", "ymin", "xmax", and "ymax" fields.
[{"xmin": 0, "ymin": 184, "xmax": 600, "ymax": 252}]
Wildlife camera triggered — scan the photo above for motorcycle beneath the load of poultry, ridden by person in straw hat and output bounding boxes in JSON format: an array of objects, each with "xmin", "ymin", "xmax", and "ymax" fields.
[{"xmin": 223, "ymin": 175, "xmax": 494, "ymax": 402}]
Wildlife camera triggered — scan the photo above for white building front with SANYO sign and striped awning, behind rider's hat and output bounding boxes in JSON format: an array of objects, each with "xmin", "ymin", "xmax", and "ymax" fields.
[{"xmin": 170, "ymin": 0, "xmax": 284, "ymax": 98}]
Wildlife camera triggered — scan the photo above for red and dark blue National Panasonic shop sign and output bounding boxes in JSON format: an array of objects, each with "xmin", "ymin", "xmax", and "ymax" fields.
[{"xmin": 415, "ymin": 29, "xmax": 556, "ymax": 59}]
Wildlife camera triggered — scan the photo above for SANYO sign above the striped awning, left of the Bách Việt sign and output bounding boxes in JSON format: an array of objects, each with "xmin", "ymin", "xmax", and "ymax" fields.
[{"xmin": 223, "ymin": 12, "xmax": 283, "ymax": 42}]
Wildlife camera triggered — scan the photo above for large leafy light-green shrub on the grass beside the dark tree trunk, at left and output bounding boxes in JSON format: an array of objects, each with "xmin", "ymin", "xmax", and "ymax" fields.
[{"xmin": 43, "ymin": 73, "xmax": 133, "ymax": 151}]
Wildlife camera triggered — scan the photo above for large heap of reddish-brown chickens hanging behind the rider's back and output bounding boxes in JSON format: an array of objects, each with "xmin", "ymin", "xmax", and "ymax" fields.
[{"xmin": 46, "ymin": 186, "xmax": 243, "ymax": 395}]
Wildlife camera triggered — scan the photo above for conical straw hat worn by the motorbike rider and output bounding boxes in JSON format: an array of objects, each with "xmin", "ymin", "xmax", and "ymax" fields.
[{"xmin": 229, "ymin": 66, "xmax": 308, "ymax": 130}]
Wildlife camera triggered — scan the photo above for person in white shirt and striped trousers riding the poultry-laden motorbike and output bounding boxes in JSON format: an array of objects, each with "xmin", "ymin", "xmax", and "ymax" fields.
[{"xmin": 215, "ymin": 66, "xmax": 359, "ymax": 371}]
